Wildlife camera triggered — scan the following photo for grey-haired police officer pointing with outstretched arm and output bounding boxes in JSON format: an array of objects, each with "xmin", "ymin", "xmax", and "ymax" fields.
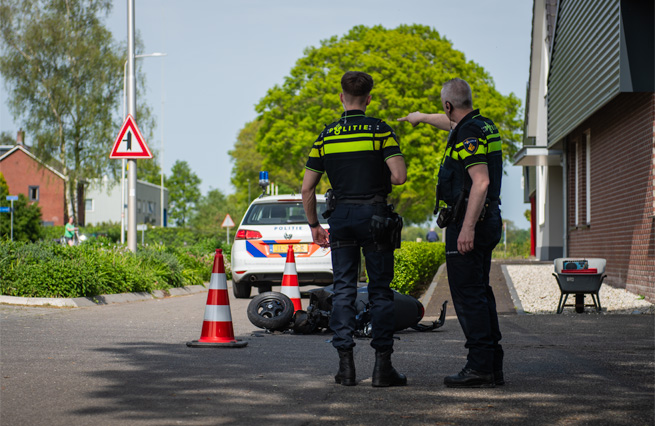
[{"xmin": 398, "ymin": 78, "xmax": 505, "ymax": 387}]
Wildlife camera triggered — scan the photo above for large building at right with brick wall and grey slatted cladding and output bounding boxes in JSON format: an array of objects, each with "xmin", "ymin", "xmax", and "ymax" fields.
[{"xmin": 514, "ymin": 0, "xmax": 655, "ymax": 302}]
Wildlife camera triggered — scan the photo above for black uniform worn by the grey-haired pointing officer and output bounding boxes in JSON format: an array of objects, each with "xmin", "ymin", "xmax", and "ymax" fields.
[{"xmin": 439, "ymin": 110, "xmax": 503, "ymax": 373}]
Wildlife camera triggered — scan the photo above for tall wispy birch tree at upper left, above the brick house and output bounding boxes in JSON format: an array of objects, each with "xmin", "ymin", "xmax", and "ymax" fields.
[{"xmin": 0, "ymin": 0, "xmax": 155, "ymax": 215}]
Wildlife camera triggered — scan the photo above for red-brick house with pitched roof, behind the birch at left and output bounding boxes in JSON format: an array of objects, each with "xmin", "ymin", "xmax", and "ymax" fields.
[{"xmin": 0, "ymin": 132, "xmax": 67, "ymax": 226}]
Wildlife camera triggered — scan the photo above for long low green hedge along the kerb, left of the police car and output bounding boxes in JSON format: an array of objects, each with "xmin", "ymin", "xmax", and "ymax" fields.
[{"xmin": 0, "ymin": 238, "xmax": 213, "ymax": 297}]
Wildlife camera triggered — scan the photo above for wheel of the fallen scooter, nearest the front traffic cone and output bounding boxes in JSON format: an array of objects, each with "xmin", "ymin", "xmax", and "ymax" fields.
[{"xmin": 247, "ymin": 291, "xmax": 293, "ymax": 331}]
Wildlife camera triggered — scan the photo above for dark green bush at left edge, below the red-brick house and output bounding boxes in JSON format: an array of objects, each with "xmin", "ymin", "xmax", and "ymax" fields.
[{"xmin": 0, "ymin": 173, "xmax": 42, "ymax": 241}]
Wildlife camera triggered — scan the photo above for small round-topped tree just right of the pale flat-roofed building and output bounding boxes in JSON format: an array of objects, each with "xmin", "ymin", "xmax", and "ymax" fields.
[{"xmin": 166, "ymin": 160, "xmax": 201, "ymax": 226}]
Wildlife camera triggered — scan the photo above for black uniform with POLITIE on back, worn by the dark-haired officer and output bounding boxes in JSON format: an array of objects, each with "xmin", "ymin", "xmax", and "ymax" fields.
[{"xmin": 306, "ymin": 110, "xmax": 402, "ymax": 351}]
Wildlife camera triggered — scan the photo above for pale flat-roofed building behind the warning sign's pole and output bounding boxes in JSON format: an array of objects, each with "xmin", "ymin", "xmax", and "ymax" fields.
[{"xmin": 84, "ymin": 176, "xmax": 168, "ymax": 226}]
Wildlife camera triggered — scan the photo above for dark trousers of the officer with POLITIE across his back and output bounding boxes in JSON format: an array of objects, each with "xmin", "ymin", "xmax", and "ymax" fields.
[{"xmin": 328, "ymin": 204, "xmax": 394, "ymax": 351}]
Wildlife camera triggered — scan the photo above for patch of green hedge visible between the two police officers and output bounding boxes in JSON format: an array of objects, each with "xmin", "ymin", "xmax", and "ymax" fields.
[{"xmin": 391, "ymin": 241, "xmax": 446, "ymax": 294}]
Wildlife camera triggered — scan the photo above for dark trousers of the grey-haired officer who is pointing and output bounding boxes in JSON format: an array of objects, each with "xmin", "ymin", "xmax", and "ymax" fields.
[{"xmin": 446, "ymin": 208, "xmax": 504, "ymax": 373}]
